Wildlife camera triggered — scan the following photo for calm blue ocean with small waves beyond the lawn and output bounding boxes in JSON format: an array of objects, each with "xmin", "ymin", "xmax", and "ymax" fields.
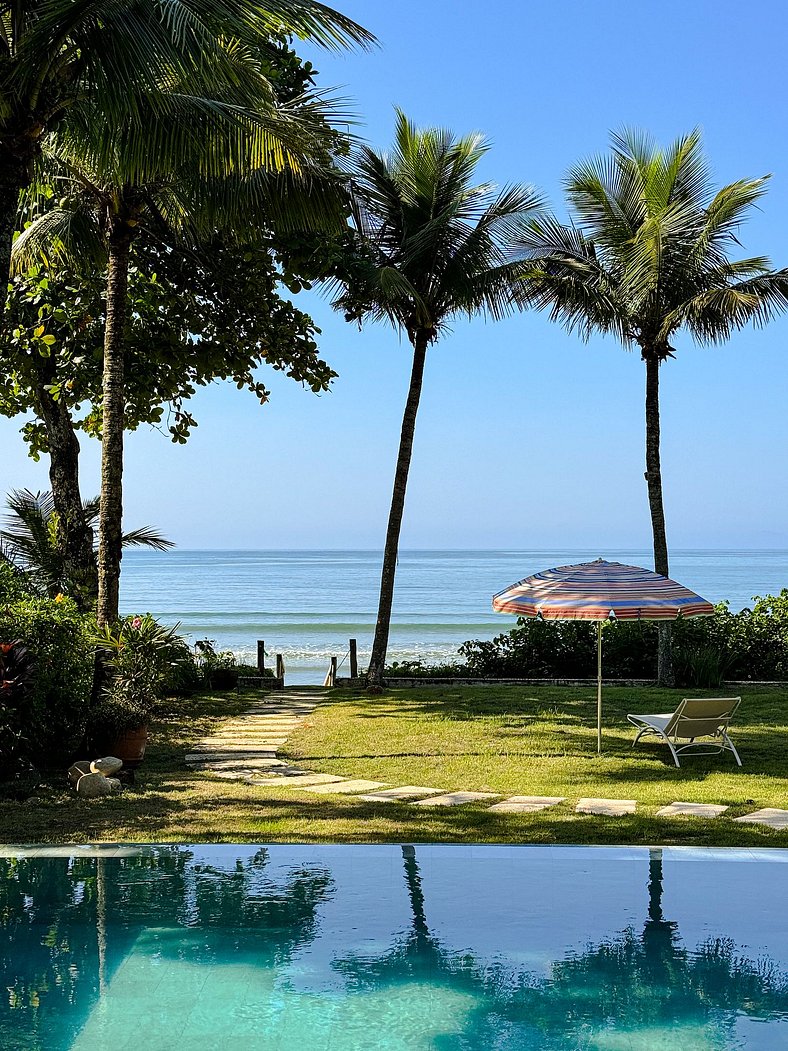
[{"xmin": 121, "ymin": 549, "xmax": 788, "ymax": 684}]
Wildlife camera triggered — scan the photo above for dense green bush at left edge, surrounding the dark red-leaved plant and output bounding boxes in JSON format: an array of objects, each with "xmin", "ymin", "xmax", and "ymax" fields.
[{"xmin": 0, "ymin": 597, "xmax": 94, "ymax": 767}]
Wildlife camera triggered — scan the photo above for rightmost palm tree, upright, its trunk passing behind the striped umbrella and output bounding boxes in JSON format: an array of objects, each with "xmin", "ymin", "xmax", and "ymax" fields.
[{"xmin": 523, "ymin": 131, "xmax": 788, "ymax": 685}]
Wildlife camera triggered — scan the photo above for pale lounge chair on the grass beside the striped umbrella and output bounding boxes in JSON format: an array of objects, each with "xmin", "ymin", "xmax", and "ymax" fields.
[{"xmin": 626, "ymin": 697, "xmax": 742, "ymax": 766}]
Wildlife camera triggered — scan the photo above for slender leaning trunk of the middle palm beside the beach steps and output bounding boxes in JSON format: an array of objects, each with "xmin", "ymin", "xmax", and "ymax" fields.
[{"xmin": 367, "ymin": 330, "xmax": 430, "ymax": 685}]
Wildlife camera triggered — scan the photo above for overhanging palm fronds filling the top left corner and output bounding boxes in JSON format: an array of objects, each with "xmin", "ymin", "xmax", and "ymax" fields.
[{"xmin": 0, "ymin": 0, "xmax": 374, "ymax": 275}]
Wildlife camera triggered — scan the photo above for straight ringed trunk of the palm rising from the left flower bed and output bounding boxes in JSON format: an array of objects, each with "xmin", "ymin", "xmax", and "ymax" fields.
[{"xmin": 97, "ymin": 222, "xmax": 133, "ymax": 627}]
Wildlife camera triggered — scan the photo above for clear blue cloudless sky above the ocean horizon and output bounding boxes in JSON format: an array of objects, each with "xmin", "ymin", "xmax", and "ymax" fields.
[{"xmin": 0, "ymin": 0, "xmax": 788, "ymax": 552}]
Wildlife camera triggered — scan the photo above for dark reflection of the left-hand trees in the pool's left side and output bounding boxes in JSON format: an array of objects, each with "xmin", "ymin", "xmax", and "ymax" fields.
[{"xmin": 0, "ymin": 846, "xmax": 332, "ymax": 1047}]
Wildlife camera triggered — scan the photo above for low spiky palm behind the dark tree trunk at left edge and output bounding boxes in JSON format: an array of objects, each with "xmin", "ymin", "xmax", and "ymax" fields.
[{"xmin": 0, "ymin": 489, "xmax": 174, "ymax": 609}]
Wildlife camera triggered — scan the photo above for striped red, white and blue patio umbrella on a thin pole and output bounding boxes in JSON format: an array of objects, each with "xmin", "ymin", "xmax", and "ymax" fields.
[{"xmin": 493, "ymin": 558, "xmax": 714, "ymax": 753}]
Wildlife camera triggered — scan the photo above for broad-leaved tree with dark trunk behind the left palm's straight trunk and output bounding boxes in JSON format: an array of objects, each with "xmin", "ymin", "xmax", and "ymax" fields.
[{"xmin": 0, "ymin": 235, "xmax": 334, "ymax": 592}]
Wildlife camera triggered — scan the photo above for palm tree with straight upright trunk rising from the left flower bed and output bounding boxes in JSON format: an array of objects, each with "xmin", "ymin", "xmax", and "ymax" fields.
[{"xmin": 14, "ymin": 61, "xmax": 355, "ymax": 626}]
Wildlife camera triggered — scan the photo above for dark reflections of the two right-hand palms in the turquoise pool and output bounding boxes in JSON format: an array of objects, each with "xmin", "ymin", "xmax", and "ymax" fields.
[{"xmin": 336, "ymin": 846, "xmax": 788, "ymax": 1048}]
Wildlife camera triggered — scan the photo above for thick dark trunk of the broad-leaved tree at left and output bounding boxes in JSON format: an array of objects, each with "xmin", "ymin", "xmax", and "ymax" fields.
[{"xmin": 36, "ymin": 375, "xmax": 97, "ymax": 610}]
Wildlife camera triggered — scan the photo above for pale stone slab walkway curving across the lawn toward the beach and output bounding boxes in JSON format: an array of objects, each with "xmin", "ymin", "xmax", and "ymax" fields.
[{"xmin": 186, "ymin": 689, "xmax": 788, "ymax": 829}]
